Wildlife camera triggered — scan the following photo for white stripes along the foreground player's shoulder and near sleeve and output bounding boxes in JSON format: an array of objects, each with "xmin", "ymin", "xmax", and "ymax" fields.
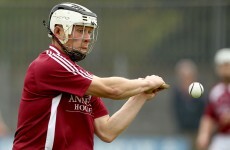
[{"xmin": 47, "ymin": 46, "xmax": 93, "ymax": 80}]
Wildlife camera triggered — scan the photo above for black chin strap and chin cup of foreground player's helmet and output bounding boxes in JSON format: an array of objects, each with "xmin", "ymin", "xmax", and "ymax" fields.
[{"xmin": 43, "ymin": 20, "xmax": 86, "ymax": 62}]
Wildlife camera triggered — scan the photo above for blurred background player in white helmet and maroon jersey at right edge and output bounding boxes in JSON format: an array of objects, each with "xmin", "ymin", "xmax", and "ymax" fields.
[{"xmin": 197, "ymin": 48, "xmax": 230, "ymax": 150}]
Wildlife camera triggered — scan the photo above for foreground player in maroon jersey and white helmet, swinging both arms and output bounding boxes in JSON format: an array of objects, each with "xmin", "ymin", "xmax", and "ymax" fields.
[{"xmin": 13, "ymin": 3, "xmax": 167, "ymax": 150}]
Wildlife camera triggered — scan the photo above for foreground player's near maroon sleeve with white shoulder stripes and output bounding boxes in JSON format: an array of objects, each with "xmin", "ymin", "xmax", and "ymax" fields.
[{"xmin": 33, "ymin": 54, "xmax": 92, "ymax": 97}]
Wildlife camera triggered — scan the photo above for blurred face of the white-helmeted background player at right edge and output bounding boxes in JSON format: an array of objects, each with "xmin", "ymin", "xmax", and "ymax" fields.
[{"xmin": 217, "ymin": 63, "xmax": 230, "ymax": 83}]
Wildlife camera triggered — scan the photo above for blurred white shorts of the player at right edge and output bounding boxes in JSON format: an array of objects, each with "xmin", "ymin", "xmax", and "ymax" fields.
[{"xmin": 209, "ymin": 134, "xmax": 230, "ymax": 150}]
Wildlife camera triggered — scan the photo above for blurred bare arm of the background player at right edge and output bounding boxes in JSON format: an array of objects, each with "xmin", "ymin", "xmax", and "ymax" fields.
[{"xmin": 197, "ymin": 116, "xmax": 215, "ymax": 150}]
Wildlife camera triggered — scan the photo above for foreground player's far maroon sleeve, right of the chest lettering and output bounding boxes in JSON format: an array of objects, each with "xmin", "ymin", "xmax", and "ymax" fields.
[{"xmin": 92, "ymin": 97, "xmax": 109, "ymax": 119}]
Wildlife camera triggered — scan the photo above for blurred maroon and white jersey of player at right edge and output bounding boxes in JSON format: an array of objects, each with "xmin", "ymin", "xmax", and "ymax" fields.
[{"xmin": 205, "ymin": 83, "xmax": 230, "ymax": 134}]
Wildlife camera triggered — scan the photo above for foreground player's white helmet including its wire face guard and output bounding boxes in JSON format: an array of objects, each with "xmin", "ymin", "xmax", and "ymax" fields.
[{"xmin": 49, "ymin": 3, "xmax": 98, "ymax": 61}]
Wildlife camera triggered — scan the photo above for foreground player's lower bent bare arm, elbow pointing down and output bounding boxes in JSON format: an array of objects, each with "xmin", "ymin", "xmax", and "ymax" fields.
[{"xmin": 94, "ymin": 93, "xmax": 155, "ymax": 142}]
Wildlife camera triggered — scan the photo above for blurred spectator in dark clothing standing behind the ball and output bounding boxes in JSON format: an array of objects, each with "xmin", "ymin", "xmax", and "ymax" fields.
[{"xmin": 172, "ymin": 59, "xmax": 205, "ymax": 147}]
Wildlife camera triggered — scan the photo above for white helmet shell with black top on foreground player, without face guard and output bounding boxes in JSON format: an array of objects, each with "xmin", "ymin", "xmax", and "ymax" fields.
[{"xmin": 49, "ymin": 2, "xmax": 97, "ymax": 44}]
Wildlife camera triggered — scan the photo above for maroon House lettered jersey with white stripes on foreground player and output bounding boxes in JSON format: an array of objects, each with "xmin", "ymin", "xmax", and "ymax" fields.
[{"xmin": 13, "ymin": 45, "xmax": 108, "ymax": 150}]
